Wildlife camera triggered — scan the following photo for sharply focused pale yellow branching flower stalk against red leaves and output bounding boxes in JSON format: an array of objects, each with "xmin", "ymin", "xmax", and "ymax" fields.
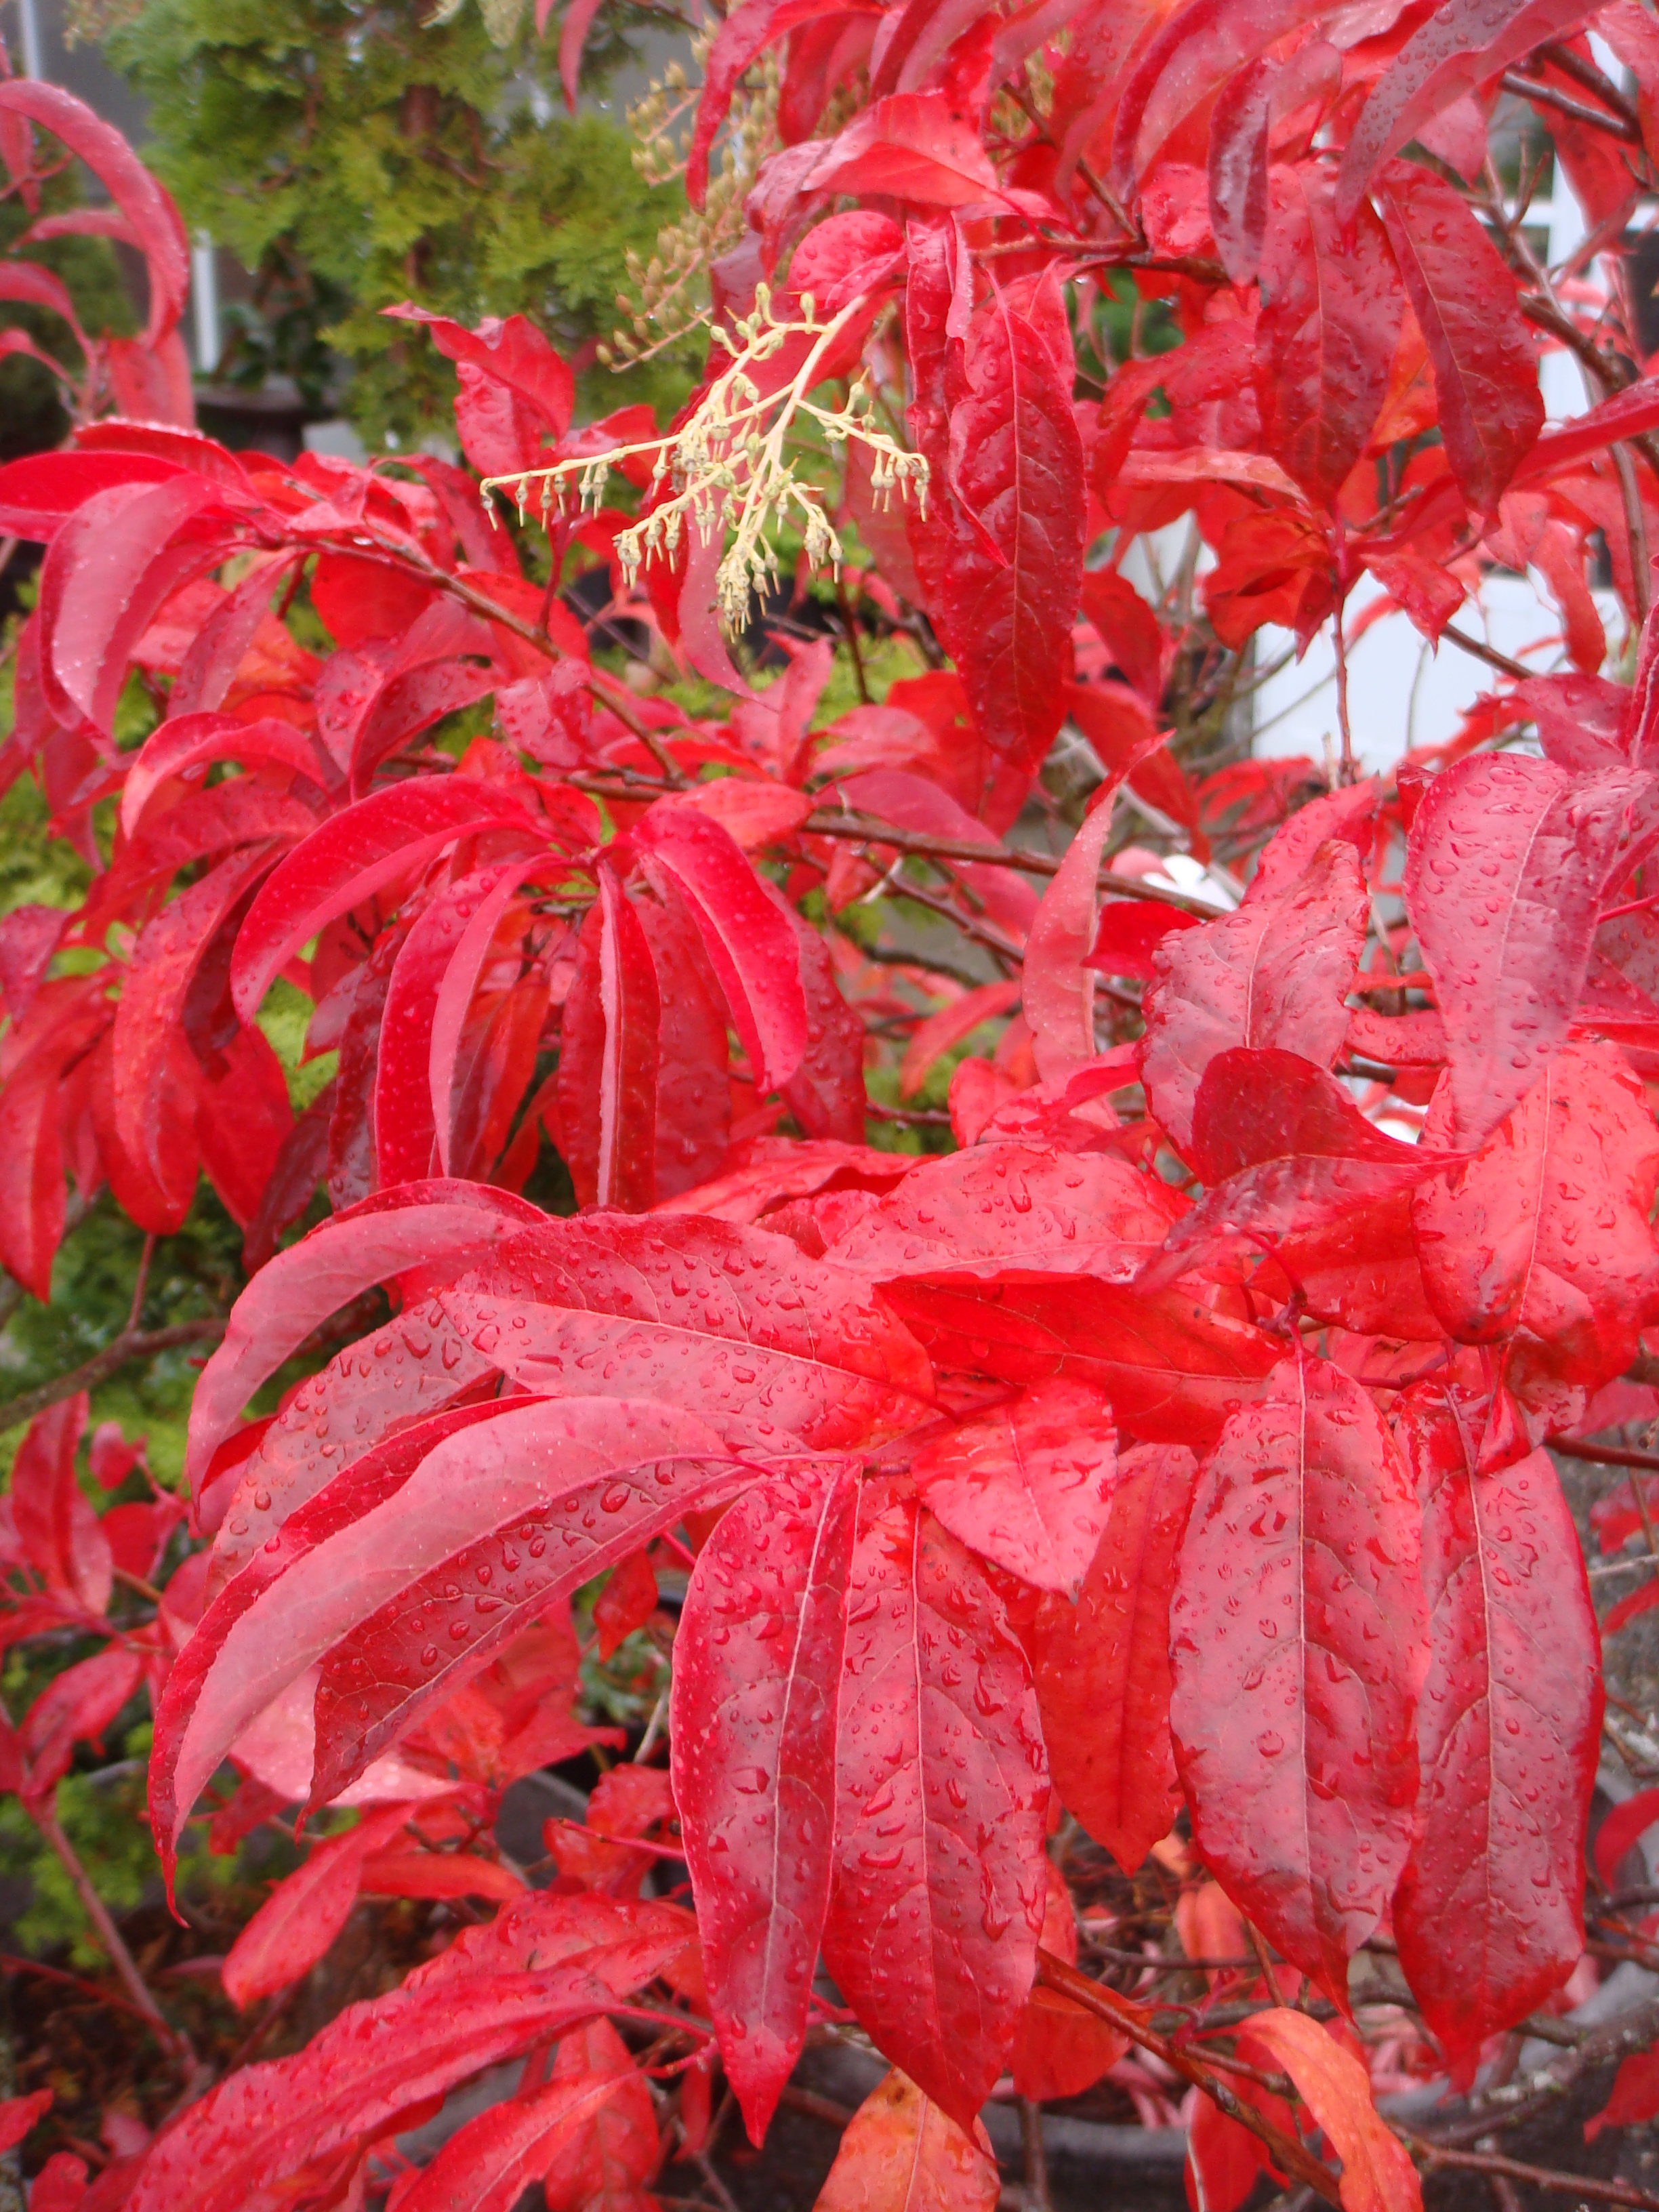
[{"xmin": 483, "ymin": 285, "xmax": 927, "ymax": 635}]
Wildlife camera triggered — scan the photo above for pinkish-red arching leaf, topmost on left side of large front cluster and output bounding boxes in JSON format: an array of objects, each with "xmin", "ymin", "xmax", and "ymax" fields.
[{"xmin": 186, "ymin": 1181, "xmax": 544, "ymax": 1495}]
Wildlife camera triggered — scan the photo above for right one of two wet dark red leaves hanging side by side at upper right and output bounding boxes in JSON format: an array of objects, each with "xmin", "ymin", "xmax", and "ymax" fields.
[{"xmin": 1382, "ymin": 167, "xmax": 1544, "ymax": 516}]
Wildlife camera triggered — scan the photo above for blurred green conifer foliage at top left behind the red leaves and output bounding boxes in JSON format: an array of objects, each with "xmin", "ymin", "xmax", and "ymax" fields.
[{"xmin": 106, "ymin": 0, "xmax": 703, "ymax": 445}]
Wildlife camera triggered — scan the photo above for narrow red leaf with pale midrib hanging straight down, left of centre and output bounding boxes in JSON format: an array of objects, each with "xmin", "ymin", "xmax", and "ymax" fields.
[{"xmin": 558, "ymin": 863, "xmax": 675, "ymax": 1214}]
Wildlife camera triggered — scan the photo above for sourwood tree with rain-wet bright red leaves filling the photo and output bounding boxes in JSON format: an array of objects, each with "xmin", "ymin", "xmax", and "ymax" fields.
[{"xmin": 0, "ymin": 0, "xmax": 1659, "ymax": 2212}]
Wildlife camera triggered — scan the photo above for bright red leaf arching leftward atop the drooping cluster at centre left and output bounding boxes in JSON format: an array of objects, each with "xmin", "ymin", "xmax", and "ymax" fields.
[{"xmin": 232, "ymin": 777, "xmax": 535, "ymax": 1022}]
